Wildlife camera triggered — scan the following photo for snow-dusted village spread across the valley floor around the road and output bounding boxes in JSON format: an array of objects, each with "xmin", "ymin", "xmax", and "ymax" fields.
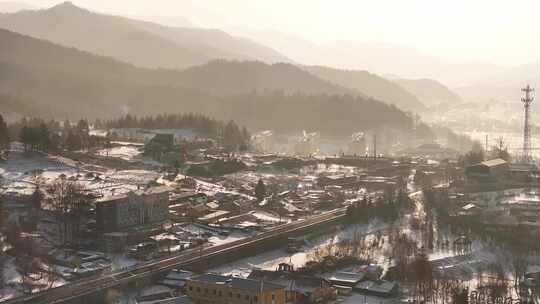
[{"xmin": 0, "ymin": 111, "xmax": 538, "ymax": 303}]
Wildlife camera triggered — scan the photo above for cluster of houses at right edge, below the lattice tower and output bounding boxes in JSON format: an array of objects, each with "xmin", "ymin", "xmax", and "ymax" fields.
[{"xmin": 428, "ymin": 158, "xmax": 540, "ymax": 234}]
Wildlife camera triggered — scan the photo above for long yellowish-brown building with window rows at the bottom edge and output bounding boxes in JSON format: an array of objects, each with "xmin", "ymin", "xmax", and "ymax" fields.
[{"xmin": 185, "ymin": 273, "xmax": 286, "ymax": 304}]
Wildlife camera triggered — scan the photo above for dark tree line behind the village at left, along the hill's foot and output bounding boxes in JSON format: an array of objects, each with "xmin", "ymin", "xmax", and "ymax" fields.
[{"xmin": 0, "ymin": 113, "xmax": 251, "ymax": 152}]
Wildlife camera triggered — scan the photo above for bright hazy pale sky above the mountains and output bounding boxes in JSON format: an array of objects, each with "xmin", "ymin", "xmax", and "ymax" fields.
[{"xmin": 19, "ymin": 0, "xmax": 540, "ymax": 65}]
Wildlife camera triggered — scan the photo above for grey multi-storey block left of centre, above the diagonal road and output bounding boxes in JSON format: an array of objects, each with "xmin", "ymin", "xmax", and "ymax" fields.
[{"xmin": 96, "ymin": 186, "xmax": 171, "ymax": 233}]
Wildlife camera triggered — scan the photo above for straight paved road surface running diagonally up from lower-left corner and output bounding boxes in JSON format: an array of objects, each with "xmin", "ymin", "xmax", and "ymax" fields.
[{"xmin": 3, "ymin": 208, "xmax": 345, "ymax": 304}]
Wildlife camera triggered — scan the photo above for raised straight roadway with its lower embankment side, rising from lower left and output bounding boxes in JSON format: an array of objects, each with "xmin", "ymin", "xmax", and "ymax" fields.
[{"xmin": 4, "ymin": 208, "xmax": 346, "ymax": 304}]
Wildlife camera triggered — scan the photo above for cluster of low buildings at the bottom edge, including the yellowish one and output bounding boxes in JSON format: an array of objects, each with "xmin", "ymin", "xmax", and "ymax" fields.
[{"xmin": 137, "ymin": 263, "xmax": 399, "ymax": 304}]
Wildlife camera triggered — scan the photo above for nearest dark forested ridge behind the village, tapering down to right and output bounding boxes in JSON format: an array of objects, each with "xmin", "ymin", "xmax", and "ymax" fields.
[{"xmin": 0, "ymin": 30, "xmax": 418, "ymax": 136}]
